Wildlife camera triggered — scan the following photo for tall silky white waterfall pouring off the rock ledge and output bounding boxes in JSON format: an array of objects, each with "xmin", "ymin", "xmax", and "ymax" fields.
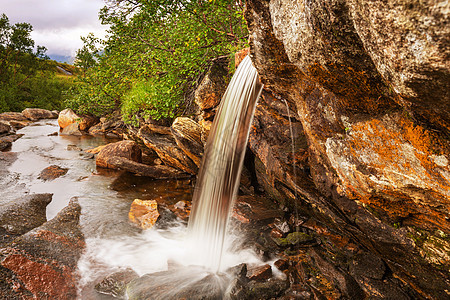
[{"xmin": 188, "ymin": 56, "xmax": 263, "ymax": 272}]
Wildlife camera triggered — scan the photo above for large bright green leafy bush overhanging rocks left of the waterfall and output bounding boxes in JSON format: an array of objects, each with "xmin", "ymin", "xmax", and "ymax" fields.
[{"xmin": 68, "ymin": 0, "xmax": 248, "ymax": 122}]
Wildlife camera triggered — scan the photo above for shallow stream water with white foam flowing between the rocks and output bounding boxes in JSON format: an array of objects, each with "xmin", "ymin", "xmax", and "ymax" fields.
[{"xmin": 0, "ymin": 120, "xmax": 260, "ymax": 299}]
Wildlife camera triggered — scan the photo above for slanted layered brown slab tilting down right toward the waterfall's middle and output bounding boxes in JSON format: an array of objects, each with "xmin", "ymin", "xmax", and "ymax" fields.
[{"xmin": 137, "ymin": 126, "xmax": 198, "ymax": 174}]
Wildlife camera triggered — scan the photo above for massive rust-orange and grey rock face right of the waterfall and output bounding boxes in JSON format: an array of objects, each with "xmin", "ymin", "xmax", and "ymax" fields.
[{"xmin": 246, "ymin": 0, "xmax": 450, "ymax": 299}]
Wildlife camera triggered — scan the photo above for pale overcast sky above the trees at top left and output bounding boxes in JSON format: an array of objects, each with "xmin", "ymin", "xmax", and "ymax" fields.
[{"xmin": 0, "ymin": 0, "xmax": 106, "ymax": 56}]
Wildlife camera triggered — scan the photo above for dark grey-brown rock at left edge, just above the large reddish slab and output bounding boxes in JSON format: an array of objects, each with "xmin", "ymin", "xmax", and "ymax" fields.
[{"xmin": 0, "ymin": 194, "xmax": 52, "ymax": 245}]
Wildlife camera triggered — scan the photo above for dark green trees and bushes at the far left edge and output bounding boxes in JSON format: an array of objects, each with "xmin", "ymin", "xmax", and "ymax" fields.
[{"xmin": 0, "ymin": 14, "xmax": 71, "ymax": 112}]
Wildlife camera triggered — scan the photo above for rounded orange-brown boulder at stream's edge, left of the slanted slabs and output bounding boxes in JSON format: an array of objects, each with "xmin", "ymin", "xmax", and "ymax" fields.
[{"xmin": 95, "ymin": 141, "xmax": 142, "ymax": 168}]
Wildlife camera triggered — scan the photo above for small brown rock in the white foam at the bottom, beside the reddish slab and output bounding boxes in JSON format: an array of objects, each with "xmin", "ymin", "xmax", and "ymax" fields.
[{"xmin": 95, "ymin": 269, "xmax": 139, "ymax": 299}]
